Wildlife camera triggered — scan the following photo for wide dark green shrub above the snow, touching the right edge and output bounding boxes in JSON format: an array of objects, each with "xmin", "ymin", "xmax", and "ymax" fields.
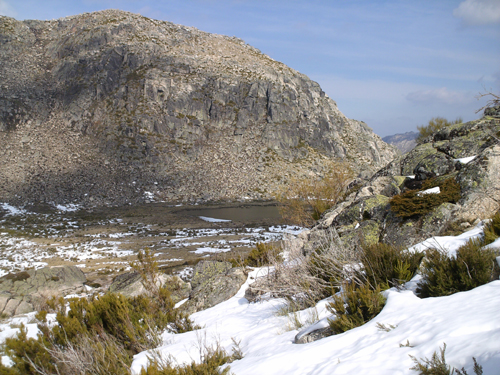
[{"xmin": 417, "ymin": 239, "xmax": 500, "ymax": 298}]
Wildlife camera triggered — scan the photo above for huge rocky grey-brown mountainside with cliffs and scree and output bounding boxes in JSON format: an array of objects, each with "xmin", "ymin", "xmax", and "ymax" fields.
[{"xmin": 0, "ymin": 10, "xmax": 396, "ymax": 205}]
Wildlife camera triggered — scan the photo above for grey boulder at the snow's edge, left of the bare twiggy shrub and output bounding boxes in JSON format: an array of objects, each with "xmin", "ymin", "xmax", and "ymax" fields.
[{"xmin": 182, "ymin": 261, "xmax": 247, "ymax": 314}]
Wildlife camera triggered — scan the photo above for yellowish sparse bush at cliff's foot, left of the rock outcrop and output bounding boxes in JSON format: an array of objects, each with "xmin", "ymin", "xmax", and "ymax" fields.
[{"xmin": 276, "ymin": 162, "xmax": 353, "ymax": 226}]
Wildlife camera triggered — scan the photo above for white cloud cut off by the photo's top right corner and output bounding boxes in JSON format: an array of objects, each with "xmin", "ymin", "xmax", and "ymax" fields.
[{"xmin": 453, "ymin": 0, "xmax": 500, "ymax": 25}]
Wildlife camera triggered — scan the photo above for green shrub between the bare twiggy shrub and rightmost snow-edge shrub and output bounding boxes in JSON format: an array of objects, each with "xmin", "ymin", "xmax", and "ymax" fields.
[{"xmin": 360, "ymin": 242, "xmax": 424, "ymax": 289}]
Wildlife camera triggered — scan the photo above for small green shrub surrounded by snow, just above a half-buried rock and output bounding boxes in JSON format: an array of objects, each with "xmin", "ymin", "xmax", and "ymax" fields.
[{"xmin": 327, "ymin": 284, "xmax": 385, "ymax": 334}]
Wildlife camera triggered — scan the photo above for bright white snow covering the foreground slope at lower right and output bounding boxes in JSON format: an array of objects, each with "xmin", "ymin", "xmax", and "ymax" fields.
[{"xmin": 132, "ymin": 226, "xmax": 500, "ymax": 375}]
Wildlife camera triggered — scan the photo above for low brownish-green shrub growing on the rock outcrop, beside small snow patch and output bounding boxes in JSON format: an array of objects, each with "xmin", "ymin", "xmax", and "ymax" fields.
[{"xmin": 390, "ymin": 178, "xmax": 461, "ymax": 218}]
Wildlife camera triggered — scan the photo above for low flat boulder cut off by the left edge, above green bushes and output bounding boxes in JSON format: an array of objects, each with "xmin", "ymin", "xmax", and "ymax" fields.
[{"xmin": 0, "ymin": 266, "xmax": 87, "ymax": 316}]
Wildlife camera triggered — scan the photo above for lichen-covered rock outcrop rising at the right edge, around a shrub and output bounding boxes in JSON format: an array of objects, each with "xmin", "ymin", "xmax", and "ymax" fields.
[{"xmin": 306, "ymin": 116, "xmax": 500, "ymax": 249}]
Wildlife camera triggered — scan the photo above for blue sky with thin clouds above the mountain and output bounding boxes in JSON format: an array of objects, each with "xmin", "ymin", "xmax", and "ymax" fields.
[{"xmin": 0, "ymin": 0, "xmax": 500, "ymax": 136}]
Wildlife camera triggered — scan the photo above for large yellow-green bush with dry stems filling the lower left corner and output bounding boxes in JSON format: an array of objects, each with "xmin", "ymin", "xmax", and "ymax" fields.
[{"xmin": 0, "ymin": 252, "xmax": 194, "ymax": 375}]
